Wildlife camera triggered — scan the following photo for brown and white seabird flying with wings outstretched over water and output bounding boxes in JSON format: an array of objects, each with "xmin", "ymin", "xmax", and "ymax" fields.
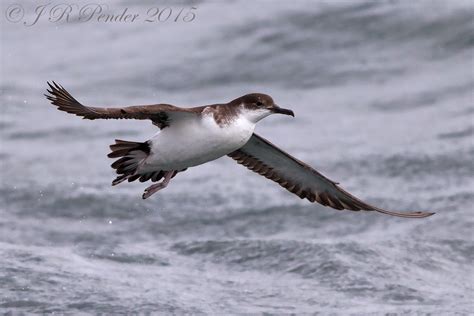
[{"xmin": 44, "ymin": 81, "xmax": 435, "ymax": 218}]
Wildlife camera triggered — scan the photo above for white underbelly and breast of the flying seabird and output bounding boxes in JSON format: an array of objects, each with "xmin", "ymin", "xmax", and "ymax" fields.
[{"xmin": 140, "ymin": 116, "xmax": 255, "ymax": 172}]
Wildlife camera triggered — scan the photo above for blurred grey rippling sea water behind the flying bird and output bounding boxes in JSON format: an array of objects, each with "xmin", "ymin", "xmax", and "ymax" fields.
[{"xmin": 0, "ymin": 0, "xmax": 474, "ymax": 315}]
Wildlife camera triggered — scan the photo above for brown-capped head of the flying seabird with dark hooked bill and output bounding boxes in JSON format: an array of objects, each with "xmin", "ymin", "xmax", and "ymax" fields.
[{"xmin": 232, "ymin": 93, "xmax": 295, "ymax": 123}]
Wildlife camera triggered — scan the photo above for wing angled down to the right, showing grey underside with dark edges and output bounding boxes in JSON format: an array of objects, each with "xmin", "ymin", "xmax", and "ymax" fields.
[{"xmin": 228, "ymin": 134, "xmax": 434, "ymax": 218}]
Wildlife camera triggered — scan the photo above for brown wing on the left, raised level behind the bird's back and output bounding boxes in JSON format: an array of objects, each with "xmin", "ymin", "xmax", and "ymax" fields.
[{"xmin": 45, "ymin": 81, "xmax": 202, "ymax": 128}]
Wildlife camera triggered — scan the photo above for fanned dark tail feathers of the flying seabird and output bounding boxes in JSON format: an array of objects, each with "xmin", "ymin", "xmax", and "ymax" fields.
[{"xmin": 107, "ymin": 139, "xmax": 151, "ymax": 185}]
